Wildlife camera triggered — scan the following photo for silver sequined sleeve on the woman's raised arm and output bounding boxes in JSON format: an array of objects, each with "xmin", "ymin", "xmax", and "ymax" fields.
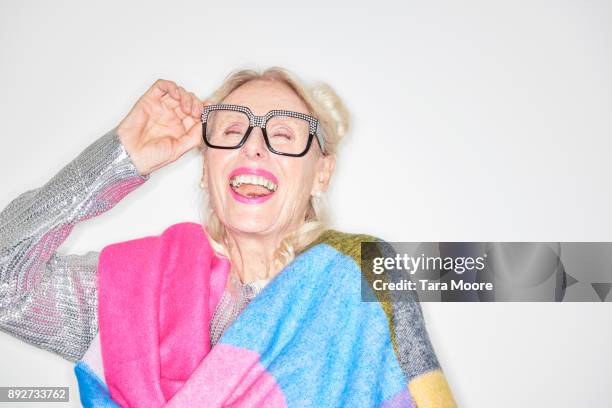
[{"xmin": 0, "ymin": 128, "xmax": 149, "ymax": 361}]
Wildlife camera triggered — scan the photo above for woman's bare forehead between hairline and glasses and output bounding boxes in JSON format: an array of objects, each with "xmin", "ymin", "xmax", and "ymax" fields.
[{"xmin": 221, "ymin": 80, "xmax": 310, "ymax": 116}]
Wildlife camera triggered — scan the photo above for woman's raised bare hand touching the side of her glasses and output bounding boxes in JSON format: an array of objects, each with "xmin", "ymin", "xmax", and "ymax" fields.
[{"xmin": 117, "ymin": 79, "xmax": 203, "ymax": 175}]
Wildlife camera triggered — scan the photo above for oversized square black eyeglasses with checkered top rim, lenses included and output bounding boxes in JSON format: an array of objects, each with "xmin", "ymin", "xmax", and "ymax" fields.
[{"xmin": 202, "ymin": 104, "xmax": 326, "ymax": 157}]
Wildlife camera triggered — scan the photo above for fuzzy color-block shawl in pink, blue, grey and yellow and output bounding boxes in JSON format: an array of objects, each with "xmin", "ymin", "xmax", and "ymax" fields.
[{"xmin": 75, "ymin": 222, "xmax": 456, "ymax": 408}]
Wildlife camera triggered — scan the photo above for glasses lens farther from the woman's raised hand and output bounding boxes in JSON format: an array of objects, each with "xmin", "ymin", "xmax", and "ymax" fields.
[{"xmin": 266, "ymin": 115, "xmax": 310, "ymax": 154}]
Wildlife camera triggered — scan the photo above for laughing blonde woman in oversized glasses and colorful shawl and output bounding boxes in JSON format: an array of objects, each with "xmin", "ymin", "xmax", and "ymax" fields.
[{"xmin": 0, "ymin": 68, "xmax": 455, "ymax": 407}]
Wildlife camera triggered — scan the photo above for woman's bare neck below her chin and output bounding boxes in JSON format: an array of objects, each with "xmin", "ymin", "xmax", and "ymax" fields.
[{"xmin": 227, "ymin": 230, "xmax": 283, "ymax": 283}]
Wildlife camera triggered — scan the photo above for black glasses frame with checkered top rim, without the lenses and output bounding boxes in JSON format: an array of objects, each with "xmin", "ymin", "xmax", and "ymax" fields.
[{"xmin": 202, "ymin": 104, "xmax": 327, "ymax": 157}]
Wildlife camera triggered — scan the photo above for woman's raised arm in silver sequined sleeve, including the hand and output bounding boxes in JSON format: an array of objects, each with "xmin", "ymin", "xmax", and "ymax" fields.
[{"xmin": 0, "ymin": 79, "xmax": 202, "ymax": 361}]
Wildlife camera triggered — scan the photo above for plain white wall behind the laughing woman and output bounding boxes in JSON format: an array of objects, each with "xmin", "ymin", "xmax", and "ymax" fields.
[{"xmin": 0, "ymin": 0, "xmax": 612, "ymax": 408}]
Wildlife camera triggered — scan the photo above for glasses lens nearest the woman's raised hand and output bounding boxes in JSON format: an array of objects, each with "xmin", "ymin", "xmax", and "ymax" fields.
[{"xmin": 206, "ymin": 109, "xmax": 249, "ymax": 147}]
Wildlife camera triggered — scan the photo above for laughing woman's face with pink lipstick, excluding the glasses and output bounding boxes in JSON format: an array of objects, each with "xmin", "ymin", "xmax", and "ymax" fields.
[{"xmin": 203, "ymin": 80, "xmax": 335, "ymax": 235}]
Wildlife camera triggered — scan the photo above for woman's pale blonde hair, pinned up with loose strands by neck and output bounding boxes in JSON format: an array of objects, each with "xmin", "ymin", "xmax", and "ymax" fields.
[{"xmin": 200, "ymin": 67, "xmax": 349, "ymax": 274}]
